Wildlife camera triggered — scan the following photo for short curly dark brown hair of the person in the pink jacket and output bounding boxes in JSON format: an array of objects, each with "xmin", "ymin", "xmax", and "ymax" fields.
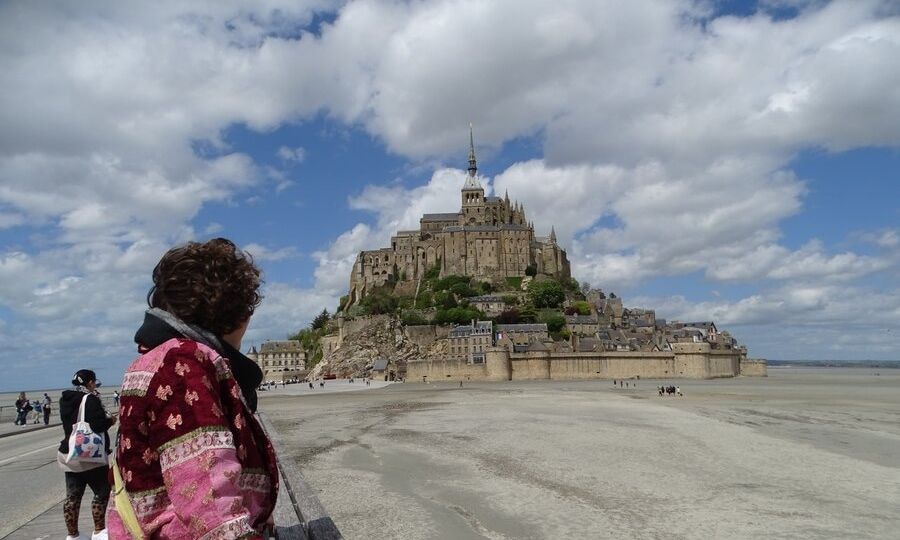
[{"xmin": 147, "ymin": 238, "xmax": 262, "ymax": 336}]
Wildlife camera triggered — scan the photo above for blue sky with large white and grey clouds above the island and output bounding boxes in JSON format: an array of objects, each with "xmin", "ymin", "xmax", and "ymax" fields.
[{"xmin": 0, "ymin": 0, "xmax": 900, "ymax": 391}]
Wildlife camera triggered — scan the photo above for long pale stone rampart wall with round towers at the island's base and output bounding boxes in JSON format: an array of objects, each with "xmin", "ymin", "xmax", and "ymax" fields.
[{"xmin": 406, "ymin": 343, "xmax": 766, "ymax": 382}]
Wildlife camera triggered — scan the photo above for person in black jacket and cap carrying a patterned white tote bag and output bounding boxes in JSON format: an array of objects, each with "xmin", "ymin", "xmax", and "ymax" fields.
[{"xmin": 57, "ymin": 369, "xmax": 116, "ymax": 540}]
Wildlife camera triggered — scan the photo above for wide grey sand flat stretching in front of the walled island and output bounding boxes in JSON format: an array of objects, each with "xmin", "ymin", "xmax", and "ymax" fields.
[{"xmin": 261, "ymin": 368, "xmax": 900, "ymax": 539}]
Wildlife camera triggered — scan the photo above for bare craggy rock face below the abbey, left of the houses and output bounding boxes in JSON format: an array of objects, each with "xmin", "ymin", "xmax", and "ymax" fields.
[{"xmin": 308, "ymin": 315, "xmax": 448, "ymax": 379}]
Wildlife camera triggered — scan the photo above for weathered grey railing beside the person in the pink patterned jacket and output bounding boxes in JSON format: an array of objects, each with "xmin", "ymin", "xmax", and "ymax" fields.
[{"xmin": 258, "ymin": 413, "xmax": 343, "ymax": 540}]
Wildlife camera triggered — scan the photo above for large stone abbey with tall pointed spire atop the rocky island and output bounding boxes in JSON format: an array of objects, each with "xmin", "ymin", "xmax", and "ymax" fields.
[{"xmin": 350, "ymin": 129, "xmax": 571, "ymax": 303}]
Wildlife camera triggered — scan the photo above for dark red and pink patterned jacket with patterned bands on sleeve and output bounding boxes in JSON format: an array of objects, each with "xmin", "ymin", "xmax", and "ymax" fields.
[{"xmin": 107, "ymin": 338, "xmax": 278, "ymax": 539}]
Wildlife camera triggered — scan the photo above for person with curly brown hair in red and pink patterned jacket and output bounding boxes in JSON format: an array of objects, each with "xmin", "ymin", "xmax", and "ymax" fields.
[{"xmin": 107, "ymin": 238, "xmax": 278, "ymax": 539}]
